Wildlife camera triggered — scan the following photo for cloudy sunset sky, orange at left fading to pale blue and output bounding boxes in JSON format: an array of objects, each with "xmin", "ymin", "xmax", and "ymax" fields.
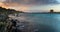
[{"xmin": 0, "ymin": 0, "xmax": 60, "ymax": 12}]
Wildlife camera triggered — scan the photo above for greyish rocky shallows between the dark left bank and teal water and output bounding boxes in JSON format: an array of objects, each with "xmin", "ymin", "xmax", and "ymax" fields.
[{"xmin": 9, "ymin": 14, "xmax": 38, "ymax": 32}]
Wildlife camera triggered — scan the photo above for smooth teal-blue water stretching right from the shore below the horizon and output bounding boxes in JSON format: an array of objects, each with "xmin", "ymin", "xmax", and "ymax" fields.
[{"xmin": 8, "ymin": 13, "xmax": 60, "ymax": 32}]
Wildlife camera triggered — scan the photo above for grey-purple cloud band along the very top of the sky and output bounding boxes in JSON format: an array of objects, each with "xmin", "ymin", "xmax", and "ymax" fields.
[{"xmin": 6, "ymin": 0, "xmax": 58, "ymax": 4}]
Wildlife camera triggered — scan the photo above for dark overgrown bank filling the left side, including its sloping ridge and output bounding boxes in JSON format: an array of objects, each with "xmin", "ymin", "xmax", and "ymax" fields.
[{"xmin": 0, "ymin": 7, "xmax": 23, "ymax": 32}]
